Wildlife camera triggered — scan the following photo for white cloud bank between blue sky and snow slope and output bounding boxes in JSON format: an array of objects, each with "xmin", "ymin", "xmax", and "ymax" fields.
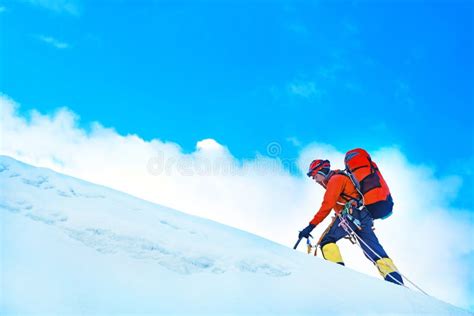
[{"xmin": 0, "ymin": 96, "xmax": 474, "ymax": 307}]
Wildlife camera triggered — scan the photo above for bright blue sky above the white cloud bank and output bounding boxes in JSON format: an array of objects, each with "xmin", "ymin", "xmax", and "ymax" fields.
[{"xmin": 0, "ymin": 0, "xmax": 474, "ymax": 207}]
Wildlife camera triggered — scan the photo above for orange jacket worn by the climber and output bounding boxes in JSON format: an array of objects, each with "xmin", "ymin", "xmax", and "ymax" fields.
[{"xmin": 310, "ymin": 173, "xmax": 360, "ymax": 225}]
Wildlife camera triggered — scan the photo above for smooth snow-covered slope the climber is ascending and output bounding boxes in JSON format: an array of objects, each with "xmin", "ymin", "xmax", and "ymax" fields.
[{"xmin": 0, "ymin": 156, "xmax": 469, "ymax": 315}]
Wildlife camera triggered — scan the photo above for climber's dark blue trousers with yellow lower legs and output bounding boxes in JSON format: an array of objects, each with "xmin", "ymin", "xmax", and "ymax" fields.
[{"xmin": 320, "ymin": 208, "xmax": 403, "ymax": 283}]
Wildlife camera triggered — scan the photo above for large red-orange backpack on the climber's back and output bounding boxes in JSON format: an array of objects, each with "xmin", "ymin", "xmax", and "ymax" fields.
[{"xmin": 344, "ymin": 148, "xmax": 391, "ymax": 206}]
